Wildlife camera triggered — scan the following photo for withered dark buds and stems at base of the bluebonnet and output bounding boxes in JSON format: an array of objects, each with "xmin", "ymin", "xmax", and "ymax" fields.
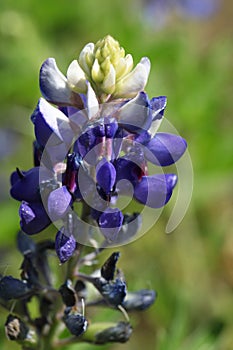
[{"xmin": 0, "ymin": 231, "xmax": 156, "ymax": 349}]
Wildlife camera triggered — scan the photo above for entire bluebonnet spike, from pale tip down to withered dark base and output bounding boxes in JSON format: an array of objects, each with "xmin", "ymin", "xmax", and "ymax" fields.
[{"xmin": 5, "ymin": 36, "xmax": 187, "ymax": 349}]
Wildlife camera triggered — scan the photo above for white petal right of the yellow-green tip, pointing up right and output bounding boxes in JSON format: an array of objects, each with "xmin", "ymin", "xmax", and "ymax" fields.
[{"xmin": 114, "ymin": 57, "xmax": 150, "ymax": 97}]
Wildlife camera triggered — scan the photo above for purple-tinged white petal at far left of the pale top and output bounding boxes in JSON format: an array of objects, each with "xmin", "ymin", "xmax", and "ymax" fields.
[{"xmin": 40, "ymin": 58, "xmax": 71, "ymax": 104}]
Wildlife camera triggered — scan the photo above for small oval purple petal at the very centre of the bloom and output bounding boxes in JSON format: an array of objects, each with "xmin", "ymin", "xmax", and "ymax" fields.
[{"xmin": 96, "ymin": 158, "xmax": 116, "ymax": 194}]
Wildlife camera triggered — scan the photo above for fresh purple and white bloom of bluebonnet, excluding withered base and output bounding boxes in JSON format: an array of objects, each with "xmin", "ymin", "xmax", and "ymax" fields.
[{"xmin": 11, "ymin": 36, "xmax": 187, "ymax": 254}]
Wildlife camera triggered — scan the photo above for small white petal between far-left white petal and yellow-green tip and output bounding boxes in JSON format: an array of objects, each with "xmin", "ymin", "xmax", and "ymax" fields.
[{"xmin": 67, "ymin": 60, "xmax": 87, "ymax": 92}]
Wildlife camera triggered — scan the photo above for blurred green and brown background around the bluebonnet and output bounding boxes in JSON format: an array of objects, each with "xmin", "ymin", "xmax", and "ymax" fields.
[{"xmin": 0, "ymin": 0, "xmax": 233, "ymax": 350}]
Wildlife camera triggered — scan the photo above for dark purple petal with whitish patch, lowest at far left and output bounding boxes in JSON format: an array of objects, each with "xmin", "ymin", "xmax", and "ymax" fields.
[{"xmin": 19, "ymin": 202, "xmax": 51, "ymax": 235}]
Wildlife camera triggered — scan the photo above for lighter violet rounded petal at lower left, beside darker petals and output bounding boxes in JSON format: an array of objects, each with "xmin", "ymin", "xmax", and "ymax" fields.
[{"xmin": 48, "ymin": 186, "xmax": 72, "ymax": 221}]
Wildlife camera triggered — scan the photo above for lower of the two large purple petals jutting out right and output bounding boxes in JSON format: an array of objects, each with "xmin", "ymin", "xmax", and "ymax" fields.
[{"xmin": 134, "ymin": 174, "xmax": 177, "ymax": 208}]
